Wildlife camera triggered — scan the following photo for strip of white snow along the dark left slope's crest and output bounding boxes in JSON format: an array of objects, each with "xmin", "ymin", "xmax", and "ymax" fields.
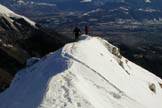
[{"xmin": 0, "ymin": 4, "xmax": 35, "ymax": 27}]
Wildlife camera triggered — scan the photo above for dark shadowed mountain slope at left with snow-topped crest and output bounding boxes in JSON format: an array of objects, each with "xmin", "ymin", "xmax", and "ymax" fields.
[{"xmin": 0, "ymin": 4, "xmax": 69, "ymax": 91}]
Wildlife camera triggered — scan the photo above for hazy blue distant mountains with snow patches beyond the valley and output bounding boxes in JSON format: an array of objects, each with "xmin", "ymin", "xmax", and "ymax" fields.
[{"xmin": 0, "ymin": 0, "xmax": 162, "ymax": 20}]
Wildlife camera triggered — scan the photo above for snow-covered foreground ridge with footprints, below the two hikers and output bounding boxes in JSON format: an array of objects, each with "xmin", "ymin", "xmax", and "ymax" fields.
[{"xmin": 0, "ymin": 35, "xmax": 162, "ymax": 108}]
